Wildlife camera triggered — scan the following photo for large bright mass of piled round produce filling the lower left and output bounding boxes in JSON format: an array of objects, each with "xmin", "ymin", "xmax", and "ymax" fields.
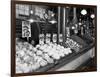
[{"xmin": 16, "ymin": 41, "xmax": 72, "ymax": 73}]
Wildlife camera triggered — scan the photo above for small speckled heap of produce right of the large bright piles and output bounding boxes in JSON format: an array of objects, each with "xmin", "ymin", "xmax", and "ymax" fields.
[{"xmin": 65, "ymin": 38, "xmax": 82, "ymax": 52}]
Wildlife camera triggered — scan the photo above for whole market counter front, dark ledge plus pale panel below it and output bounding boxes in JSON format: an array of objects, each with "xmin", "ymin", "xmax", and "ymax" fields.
[{"xmin": 35, "ymin": 44, "xmax": 94, "ymax": 72}]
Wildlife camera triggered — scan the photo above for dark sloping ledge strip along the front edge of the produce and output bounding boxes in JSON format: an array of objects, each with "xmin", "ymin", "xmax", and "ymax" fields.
[{"xmin": 30, "ymin": 44, "xmax": 94, "ymax": 72}]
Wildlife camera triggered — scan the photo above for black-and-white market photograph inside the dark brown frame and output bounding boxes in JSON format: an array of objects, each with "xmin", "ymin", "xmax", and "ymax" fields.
[{"xmin": 14, "ymin": 2, "xmax": 97, "ymax": 74}]
